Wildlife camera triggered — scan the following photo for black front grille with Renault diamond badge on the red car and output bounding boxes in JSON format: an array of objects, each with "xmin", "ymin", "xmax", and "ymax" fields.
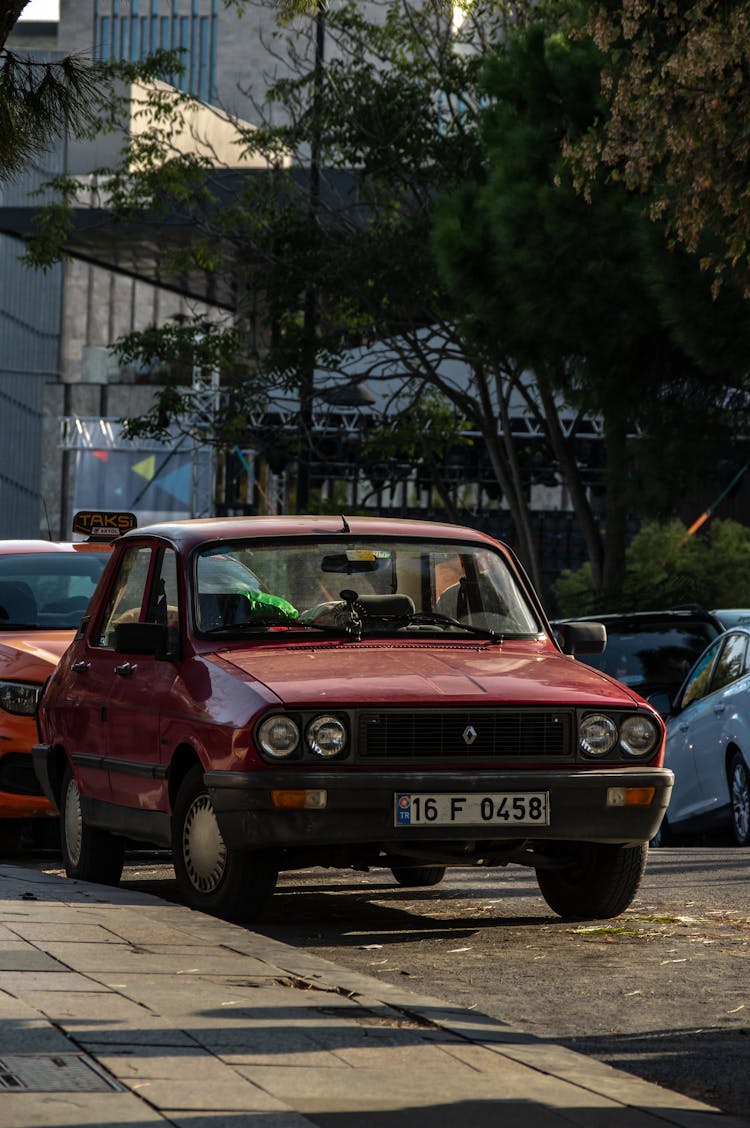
[{"xmin": 358, "ymin": 708, "xmax": 575, "ymax": 763}]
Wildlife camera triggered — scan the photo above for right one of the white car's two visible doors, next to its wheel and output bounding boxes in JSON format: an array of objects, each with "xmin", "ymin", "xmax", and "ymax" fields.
[{"xmin": 694, "ymin": 632, "xmax": 750, "ymax": 811}]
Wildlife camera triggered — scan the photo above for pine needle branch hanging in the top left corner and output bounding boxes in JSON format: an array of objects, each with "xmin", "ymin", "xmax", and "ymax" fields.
[{"xmin": 0, "ymin": 0, "xmax": 102, "ymax": 182}]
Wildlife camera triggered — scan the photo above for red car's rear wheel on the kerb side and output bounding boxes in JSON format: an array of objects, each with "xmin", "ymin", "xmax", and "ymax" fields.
[{"xmin": 60, "ymin": 765, "xmax": 125, "ymax": 885}]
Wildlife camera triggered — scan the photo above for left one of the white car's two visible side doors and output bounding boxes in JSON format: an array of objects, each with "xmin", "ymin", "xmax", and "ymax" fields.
[{"xmin": 665, "ymin": 640, "xmax": 721, "ymax": 825}]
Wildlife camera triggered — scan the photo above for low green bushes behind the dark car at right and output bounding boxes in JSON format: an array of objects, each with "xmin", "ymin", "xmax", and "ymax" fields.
[{"xmin": 555, "ymin": 520, "xmax": 750, "ymax": 616}]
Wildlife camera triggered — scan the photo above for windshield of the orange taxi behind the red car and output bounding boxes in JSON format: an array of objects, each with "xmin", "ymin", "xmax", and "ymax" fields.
[{"xmin": 0, "ymin": 552, "xmax": 108, "ymax": 631}]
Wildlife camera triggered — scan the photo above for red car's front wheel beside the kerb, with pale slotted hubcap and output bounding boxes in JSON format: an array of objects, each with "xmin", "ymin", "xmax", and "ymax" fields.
[{"xmin": 171, "ymin": 765, "xmax": 279, "ymax": 923}]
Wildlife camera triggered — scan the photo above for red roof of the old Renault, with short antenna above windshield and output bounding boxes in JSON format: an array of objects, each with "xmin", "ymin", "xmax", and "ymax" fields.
[{"xmin": 120, "ymin": 515, "xmax": 504, "ymax": 549}]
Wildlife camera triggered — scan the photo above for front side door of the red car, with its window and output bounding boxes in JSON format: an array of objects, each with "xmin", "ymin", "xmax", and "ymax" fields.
[{"xmin": 102, "ymin": 545, "xmax": 179, "ymax": 811}]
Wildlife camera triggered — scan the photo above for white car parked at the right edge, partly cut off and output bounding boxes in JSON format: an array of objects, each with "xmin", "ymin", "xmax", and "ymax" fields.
[{"xmin": 658, "ymin": 627, "xmax": 750, "ymax": 846}]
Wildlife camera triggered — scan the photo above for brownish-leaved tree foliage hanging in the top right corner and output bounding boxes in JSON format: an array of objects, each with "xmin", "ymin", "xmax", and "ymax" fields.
[{"xmin": 572, "ymin": 0, "xmax": 750, "ymax": 296}]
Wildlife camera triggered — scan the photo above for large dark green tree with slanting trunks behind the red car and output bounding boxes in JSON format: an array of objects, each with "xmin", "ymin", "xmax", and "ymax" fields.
[{"xmin": 20, "ymin": 0, "xmax": 744, "ymax": 590}]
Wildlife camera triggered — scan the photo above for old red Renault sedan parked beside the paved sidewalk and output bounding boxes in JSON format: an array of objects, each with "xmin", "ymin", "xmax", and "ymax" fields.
[{"xmin": 34, "ymin": 517, "xmax": 672, "ymax": 920}]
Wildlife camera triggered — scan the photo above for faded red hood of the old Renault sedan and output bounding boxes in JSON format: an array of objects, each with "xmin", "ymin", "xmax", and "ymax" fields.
[{"xmin": 217, "ymin": 642, "xmax": 639, "ymax": 708}]
